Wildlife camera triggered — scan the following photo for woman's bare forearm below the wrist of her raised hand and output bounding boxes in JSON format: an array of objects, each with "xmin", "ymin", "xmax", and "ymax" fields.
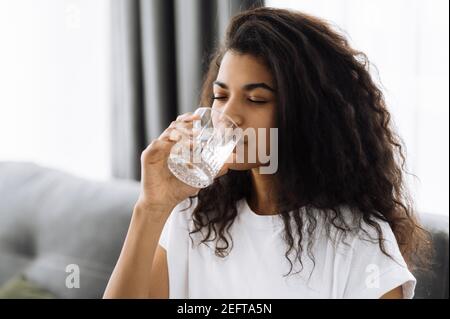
[{"xmin": 103, "ymin": 204, "xmax": 171, "ymax": 298}]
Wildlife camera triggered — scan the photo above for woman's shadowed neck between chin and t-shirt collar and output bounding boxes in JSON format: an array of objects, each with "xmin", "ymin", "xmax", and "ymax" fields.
[{"xmin": 248, "ymin": 168, "xmax": 278, "ymax": 215}]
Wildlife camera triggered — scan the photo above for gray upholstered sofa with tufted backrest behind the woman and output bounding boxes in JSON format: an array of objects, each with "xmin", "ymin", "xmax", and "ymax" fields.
[{"xmin": 0, "ymin": 162, "xmax": 449, "ymax": 298}]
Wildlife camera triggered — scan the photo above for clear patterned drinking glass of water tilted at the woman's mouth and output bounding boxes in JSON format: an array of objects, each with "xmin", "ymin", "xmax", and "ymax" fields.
[{"xmin": 167, "ymin": 107, "xmax": 242, "ymax": 188}]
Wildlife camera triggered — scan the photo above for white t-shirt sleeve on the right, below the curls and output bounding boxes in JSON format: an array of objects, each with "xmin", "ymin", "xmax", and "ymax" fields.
[{"xmin": 344, "ymin": 221, "xmax": 416, "ymax": 299}]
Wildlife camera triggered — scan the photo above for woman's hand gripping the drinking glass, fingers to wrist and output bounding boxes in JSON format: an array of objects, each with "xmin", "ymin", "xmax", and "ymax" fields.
[{"xmin": 137, "ymin": 113, "xmax": 199, "ymax": 213}]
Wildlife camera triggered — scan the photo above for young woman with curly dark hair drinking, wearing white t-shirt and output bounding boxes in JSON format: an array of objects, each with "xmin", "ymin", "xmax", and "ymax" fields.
[{"xmin": 104, "ymin": 8, "xmax": 429, "ymax": 298}]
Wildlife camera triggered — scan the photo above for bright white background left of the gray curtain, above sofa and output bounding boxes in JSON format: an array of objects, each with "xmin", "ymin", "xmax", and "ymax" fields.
[{"xmin": 0, "ymin": 0, "xmax": 111, "ymax": 179}]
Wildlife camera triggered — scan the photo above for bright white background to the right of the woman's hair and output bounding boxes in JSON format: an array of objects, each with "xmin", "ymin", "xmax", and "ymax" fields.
[{"xmin": 266, "ymin": 0, "xmax": 449, "ymax": 214}]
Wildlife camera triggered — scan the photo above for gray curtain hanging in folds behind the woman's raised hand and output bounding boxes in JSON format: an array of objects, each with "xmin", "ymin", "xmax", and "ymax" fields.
[{"xmin": 111, "ymin": 0, "xmax": 263, "ymax": 179}]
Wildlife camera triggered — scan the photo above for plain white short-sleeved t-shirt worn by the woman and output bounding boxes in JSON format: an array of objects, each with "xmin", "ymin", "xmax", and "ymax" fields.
[{"xmin": 159, "ymin": 199, "xmax": 416, "ymax": 299}]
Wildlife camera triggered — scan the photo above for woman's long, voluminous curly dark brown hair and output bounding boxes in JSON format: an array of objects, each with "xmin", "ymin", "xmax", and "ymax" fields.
[{"xmin": 184, "ymin": 7, "xmax": 431, "ymax": 274}]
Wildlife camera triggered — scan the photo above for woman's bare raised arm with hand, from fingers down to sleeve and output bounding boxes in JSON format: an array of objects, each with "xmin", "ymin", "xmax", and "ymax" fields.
[{"xmin": 103, "ymin": 114, "xmax": 198, "ymax": 298}]
